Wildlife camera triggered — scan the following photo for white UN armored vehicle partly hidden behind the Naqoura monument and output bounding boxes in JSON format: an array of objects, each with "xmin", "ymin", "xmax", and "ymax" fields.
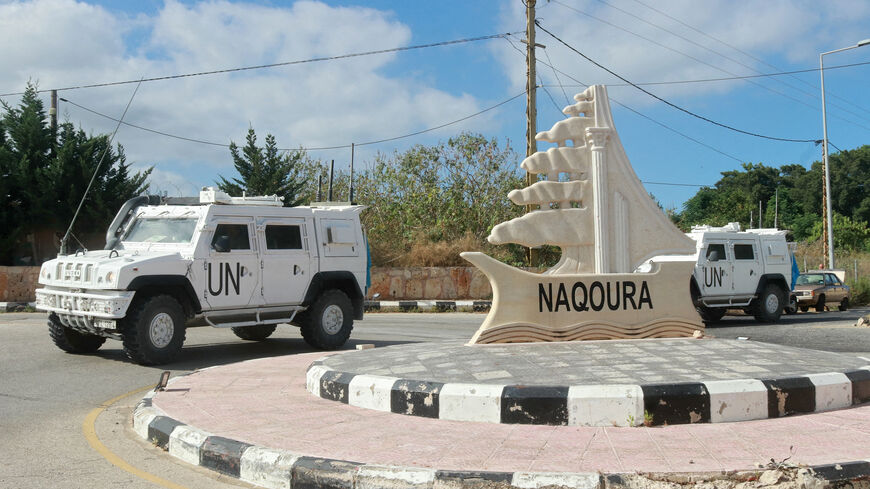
[{"xmin": 640, "ymin": 222, "xmax": 796, "ymax": 323}]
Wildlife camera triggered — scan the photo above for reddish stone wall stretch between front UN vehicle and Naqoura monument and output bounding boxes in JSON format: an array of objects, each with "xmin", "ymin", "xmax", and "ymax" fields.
[{"xmin": 368, "ymin": 267, "xmax": 492, "ymax": 301}]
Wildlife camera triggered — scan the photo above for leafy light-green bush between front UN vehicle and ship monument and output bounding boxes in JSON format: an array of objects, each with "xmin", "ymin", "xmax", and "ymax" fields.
[{"xmin": 355, "ymin": 133, "xmax": 523, "ymax": 260}]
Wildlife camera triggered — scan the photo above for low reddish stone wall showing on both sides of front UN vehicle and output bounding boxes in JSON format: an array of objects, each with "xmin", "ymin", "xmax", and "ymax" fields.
[{"xmin": 0, "ymin": 267, "xmax": 492, "ymax": 302}]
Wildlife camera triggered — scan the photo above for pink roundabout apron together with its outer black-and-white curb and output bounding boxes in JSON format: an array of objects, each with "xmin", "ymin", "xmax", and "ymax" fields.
[{"xmin": 134, "ymin": 347, "xmax": 870, "ymax": 488}]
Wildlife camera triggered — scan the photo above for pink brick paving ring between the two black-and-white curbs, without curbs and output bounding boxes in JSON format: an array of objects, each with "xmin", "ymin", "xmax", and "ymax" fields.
[{"xmin": 153, "ymin": 350, "xmax": 870, "ymax": 473}]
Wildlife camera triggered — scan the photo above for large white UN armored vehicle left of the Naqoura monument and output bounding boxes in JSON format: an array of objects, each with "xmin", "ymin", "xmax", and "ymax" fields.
[{"xmin": 36, "ymin": 188, "xmax": 368, "ymax": 365}]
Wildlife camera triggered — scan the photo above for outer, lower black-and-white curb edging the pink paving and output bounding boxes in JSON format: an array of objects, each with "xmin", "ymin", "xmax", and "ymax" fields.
[{"xmin": 133, "ymin": 392, "xmax": 870, "ymax": 489}]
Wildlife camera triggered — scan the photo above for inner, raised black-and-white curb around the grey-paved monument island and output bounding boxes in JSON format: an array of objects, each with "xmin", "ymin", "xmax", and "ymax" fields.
[{"xmin": 306, "ymin": 358, "xmax": 870, "ymax": 426}]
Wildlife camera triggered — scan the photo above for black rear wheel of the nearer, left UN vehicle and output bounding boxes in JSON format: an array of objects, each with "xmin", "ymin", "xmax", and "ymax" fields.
[{"xmin": 302, "ymin": 289, "xmax": 353, "ymax": 350}]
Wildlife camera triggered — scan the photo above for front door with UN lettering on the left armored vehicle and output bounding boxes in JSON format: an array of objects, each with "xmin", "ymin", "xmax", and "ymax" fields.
[{"xmin": 202, "ymin": 216, "xmax": 260, "ymax": 309}]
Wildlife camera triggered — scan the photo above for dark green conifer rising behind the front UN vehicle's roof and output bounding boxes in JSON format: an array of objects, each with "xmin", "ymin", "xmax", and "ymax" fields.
[{"xmin": 216, "ymin": 127, "xmax": 305, "ymax": 207}]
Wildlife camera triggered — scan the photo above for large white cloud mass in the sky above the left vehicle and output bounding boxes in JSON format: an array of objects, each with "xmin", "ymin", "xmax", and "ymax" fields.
[{"xmin": 0, "ymin": 0, "xmax": 497, "ymax": 195}]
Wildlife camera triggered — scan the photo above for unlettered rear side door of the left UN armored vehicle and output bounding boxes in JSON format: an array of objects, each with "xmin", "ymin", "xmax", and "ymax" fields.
[{"xmin": 257, "ymin": 217, "xmax": 311, "ymax": 306}]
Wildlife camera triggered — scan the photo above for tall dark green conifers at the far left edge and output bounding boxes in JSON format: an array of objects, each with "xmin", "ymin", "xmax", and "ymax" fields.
[{"xmin": 0, "ymin": 83, "xmax": 151, "ymax": 264}]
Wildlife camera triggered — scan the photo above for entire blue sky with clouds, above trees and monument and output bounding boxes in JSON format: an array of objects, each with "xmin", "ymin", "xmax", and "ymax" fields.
[{"xmin": 0, "ymin": 0, "xmax": 870, "ymax": 208}]
